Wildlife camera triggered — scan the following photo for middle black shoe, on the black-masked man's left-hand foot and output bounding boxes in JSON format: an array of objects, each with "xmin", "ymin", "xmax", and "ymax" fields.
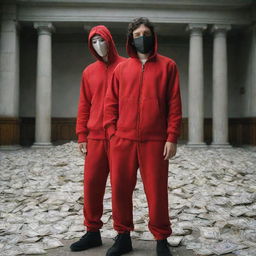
[{"xmin": 106, "ymin": 233, "xmax": 133, "ymax": 256}]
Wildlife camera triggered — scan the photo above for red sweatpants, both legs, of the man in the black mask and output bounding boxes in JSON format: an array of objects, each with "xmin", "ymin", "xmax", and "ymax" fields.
[{"xmin": 109, "ymin": 135, "xmax": 172, "ymax": 240}]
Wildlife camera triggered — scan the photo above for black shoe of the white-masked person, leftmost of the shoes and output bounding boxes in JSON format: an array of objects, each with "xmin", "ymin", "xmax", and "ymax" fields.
[{"xmin": 70, "ymin": 231, "xmax": 102, "ymax": 252}]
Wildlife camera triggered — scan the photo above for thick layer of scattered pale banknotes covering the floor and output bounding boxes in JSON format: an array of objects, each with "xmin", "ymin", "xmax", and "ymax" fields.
[{"xmin": 0, "ymin": 142, "xmax": 256, "ymax": 256}]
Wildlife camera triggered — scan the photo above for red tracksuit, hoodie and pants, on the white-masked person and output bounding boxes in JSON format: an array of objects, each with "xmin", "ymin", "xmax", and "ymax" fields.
[{"xmin": 76, "ymin": 26, "xmax": 125, "ymax": 231}]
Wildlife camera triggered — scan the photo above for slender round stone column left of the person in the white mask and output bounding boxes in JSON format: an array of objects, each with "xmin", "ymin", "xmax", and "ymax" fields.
[{"xmin": 32, "ymin": 22, "xmax": 54, "ymax": 148}]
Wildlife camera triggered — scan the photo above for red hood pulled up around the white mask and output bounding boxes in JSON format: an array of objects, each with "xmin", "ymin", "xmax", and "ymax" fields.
[{"xmin": 88, "ymin": 25, "xmax": 118, "ymax": 63}]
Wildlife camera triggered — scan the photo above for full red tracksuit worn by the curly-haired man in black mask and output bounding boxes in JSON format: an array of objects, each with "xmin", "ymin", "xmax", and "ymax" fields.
[{"xmin": 103, "ymin": 31, "xmax": 182, "ymax": 240}]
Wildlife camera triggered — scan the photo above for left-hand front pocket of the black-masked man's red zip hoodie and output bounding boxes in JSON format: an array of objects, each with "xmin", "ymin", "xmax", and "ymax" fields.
[{"xmin": 117, "ymin": 98, "xmax": 138, "ymax": 131}]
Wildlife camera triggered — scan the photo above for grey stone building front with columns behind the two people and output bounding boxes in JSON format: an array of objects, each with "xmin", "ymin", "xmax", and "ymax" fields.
[{"xmin": 0, "ymin": 0, "xmax": 256, "ymax": 149}]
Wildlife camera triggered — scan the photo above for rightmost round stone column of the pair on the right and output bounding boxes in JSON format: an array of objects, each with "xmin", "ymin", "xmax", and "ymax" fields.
[{"xmin": 211, "ymin": 25, "xmax": 231, "ymax": 147}]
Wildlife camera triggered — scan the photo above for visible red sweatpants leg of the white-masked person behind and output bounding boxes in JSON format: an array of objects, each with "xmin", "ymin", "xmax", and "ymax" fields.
[{"xmin": 83, "ymin": 139, "xmax": 109, "ymax": 231}]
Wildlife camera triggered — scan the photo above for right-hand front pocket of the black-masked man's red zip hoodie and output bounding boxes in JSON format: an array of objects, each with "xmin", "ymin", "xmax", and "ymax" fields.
[{"xmin": 140, "ymin": 98, "xmax": 166, "ymax": 133}]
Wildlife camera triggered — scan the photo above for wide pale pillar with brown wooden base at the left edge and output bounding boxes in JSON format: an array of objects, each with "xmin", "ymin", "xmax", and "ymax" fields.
[{"xmin": 0, "ymin": 4, "xmax": 20, "ymax": 150}]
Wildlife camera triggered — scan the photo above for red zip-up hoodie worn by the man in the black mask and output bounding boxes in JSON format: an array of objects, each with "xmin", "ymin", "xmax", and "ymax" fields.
[{"xmin": 103, "ymin": 30, "xmax": 182, "ymax": 143}]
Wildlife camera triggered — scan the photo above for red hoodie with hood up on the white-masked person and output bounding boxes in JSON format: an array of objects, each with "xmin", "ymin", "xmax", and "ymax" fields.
[{"xmin": 76, "ymin": 25, "xmax": 125, "ymax": 143}]
